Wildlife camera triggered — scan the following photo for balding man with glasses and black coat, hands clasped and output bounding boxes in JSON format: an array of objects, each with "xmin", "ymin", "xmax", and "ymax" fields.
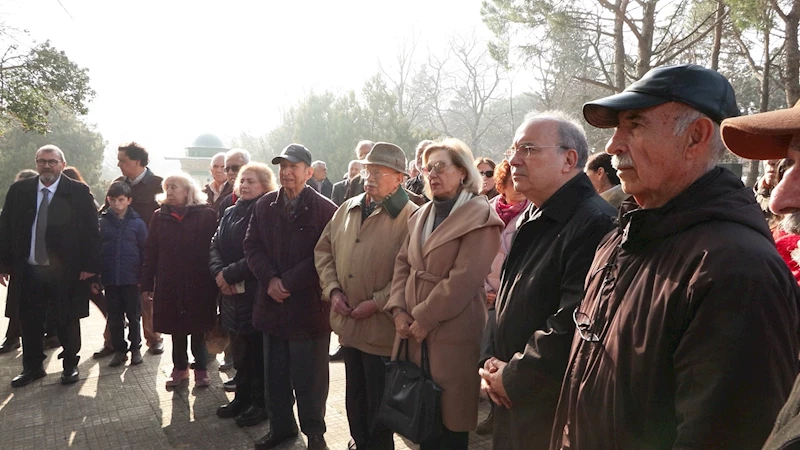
[{"xmin": 480, "ymin": 112, "xmax": 616, "ymax": 449}]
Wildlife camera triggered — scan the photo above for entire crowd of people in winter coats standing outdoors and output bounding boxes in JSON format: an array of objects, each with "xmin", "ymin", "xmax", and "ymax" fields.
[{"xmin": 0, "ymin": 65, "xmax": 800, "ymax": 450}]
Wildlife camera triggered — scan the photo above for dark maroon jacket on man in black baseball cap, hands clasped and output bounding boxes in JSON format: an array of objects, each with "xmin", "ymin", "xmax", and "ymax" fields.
[{"xmin": 244, "ymin": 188, "xmax": 336, "ymax": 339}]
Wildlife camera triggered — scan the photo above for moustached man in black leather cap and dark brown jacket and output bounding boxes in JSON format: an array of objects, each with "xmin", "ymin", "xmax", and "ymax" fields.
[{"xmin": 550, "ymin": 65, "xmax": 798, "ymax": 450}]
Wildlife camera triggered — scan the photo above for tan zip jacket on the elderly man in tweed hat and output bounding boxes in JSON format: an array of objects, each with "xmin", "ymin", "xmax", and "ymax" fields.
[{"xmin": 314, "ymin": 194, "xmax": 417, "ymax": 356}]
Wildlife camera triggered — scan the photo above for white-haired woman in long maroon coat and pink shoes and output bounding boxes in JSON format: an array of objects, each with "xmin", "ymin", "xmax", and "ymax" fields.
[{"xmin": 141, "ymin": 173, "xmax": 217, "ymax": 388}]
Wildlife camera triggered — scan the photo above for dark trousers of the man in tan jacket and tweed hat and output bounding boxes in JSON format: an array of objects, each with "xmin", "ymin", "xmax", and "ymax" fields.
[{"xmin": 342, "ymin": 347, "xmax": 394, "ymax": 450}]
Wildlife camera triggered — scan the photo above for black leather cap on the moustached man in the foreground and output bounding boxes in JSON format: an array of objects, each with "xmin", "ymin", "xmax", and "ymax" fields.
[{"xmin": 583, "ymin": 64, "xmax": 739, "ymax": 128}]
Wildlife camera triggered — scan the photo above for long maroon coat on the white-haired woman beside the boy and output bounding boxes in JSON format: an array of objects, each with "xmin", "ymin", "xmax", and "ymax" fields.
[{"xmin": 141, "ymin": 205, "xmax": 217, "ymax": 334}]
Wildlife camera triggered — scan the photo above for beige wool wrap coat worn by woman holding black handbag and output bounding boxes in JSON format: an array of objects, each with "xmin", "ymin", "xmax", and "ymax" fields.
[{"xmin": 386, "ymin": 195, "xmax": 503, "ymax": 431}]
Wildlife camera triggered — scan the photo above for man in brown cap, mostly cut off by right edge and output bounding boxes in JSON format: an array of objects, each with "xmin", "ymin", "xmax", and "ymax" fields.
[{"xmin": 722, "ymin": 102, "xmax": 800, "ymax": 450}]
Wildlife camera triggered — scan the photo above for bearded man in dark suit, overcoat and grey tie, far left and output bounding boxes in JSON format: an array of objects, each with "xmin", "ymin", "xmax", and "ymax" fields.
[{"xmin": 0, "ymin": 145, "xmax": 100, "ymax": 387}]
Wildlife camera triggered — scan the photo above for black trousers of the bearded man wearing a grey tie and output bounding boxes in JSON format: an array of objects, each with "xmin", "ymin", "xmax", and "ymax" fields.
[{"xmin": 19, "ymin": 265, "xmax": 81, "ymax": 370}]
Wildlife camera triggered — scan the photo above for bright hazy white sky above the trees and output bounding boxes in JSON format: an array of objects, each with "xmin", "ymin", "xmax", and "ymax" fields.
[{"xmin": 0, "ymin": 0, "xmax": 488, "ymax": 169}]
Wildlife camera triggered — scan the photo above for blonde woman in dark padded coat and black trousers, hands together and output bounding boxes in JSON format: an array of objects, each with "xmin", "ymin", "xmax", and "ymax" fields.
[{"xmin": 210, "ymin": 163, "xmax": 277, "ymax": 426}]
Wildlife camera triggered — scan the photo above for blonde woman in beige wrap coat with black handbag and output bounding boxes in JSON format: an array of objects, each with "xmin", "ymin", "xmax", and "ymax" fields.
[{"xmin": 385, "ymin": 139, "xmax": 503, "ymax": 450}]
